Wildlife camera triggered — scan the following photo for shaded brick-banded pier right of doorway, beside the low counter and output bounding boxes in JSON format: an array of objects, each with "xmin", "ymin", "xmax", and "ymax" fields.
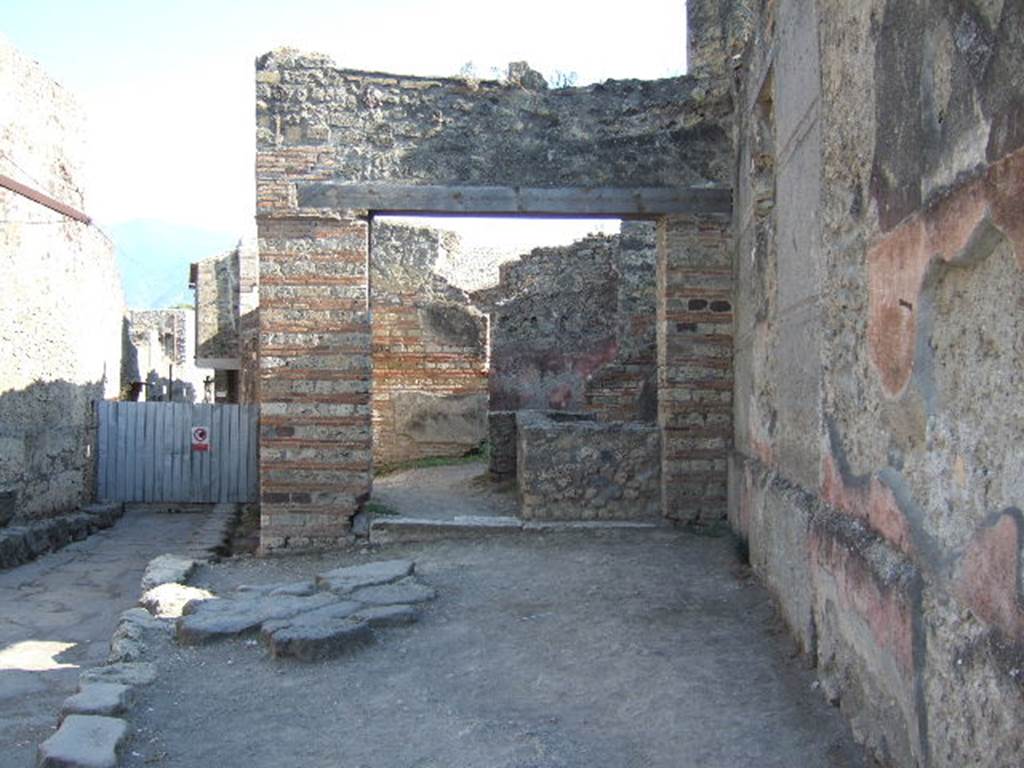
[{"xmin": 657, "ymin": 216, "xmax": 733, "ymax": 526}]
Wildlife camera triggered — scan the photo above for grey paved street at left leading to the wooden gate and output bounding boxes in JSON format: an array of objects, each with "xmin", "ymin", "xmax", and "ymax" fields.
[{"xmin": 0, "ymin": 507, "xmax": 205, "ymax": 768}]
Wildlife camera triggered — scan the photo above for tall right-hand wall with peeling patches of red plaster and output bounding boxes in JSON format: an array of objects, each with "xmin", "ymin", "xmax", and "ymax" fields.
[{"xmin": 729, "ymin": 0, "xmax": 1024, "ymax": 766}]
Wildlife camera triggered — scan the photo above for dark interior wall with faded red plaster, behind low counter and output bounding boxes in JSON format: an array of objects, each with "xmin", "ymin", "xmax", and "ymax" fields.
[{"xmin": 473, "ymin": 222, "xmax": 657, "ymax": 422}]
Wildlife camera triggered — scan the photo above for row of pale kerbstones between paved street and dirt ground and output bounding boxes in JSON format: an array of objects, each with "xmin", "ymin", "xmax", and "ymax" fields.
[{"xmin": 37, "ymin": 504, "xmax": 240, "ymax": 768}]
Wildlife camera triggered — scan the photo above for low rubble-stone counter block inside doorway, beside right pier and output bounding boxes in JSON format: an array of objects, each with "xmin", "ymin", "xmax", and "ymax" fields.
[{"xmin": 516, "ymin": 411, "xmax": 660, "ymax": 520}]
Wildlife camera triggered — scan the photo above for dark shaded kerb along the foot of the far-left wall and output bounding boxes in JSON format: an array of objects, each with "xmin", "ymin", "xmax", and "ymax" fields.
[{"xmin": 0, "ymin": 504, "xmax": 124, "ymax": 570}]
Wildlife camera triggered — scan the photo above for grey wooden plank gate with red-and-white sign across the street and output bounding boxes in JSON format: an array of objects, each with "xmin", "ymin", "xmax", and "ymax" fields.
[{"xmin": 96, "ymin": 401, "xmax": 258, "ymax": 503}]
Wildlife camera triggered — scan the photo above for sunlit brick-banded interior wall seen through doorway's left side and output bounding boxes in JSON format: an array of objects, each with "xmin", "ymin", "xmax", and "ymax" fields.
[{"xmin": 370, "ymin": 221, "xmax": 487, "ymax": 467}]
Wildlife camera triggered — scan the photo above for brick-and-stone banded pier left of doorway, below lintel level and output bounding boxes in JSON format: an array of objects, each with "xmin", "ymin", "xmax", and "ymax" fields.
[{"xmin": 258, "ymin": 214, "xmax": 372, "ymax": 551}]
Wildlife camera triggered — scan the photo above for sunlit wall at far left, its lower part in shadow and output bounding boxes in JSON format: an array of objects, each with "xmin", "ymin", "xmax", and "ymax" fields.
[{"xmin": 0, "ymin": 38, "xmax": 123, "ymax": 519}]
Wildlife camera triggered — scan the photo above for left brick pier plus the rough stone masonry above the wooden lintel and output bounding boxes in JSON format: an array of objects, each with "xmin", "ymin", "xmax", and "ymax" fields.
[{"xmin": 256, "ymin": 50, "xmax": 732, "ymax": 550}]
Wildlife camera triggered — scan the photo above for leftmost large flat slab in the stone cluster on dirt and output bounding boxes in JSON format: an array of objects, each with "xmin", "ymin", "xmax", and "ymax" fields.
[{"xmin": 177, "ymin": 593, "xmax": 338, "ymax": 645}]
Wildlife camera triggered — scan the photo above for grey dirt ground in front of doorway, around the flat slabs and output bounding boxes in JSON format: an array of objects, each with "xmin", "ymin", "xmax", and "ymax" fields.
[{"xmin": 125, "ymin": 529, "xmax": 865, "ymax": 768}]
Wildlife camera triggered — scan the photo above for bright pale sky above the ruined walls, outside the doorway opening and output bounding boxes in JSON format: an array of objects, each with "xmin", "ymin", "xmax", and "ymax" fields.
[{"xmin": 0, "ymin": 0, "xmax": 686, "ymax": 303}]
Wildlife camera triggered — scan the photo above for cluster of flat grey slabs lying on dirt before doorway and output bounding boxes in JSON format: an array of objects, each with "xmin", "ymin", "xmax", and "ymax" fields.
[{"xmin": 176, "ymin": 560, "xmax": 436, "ymax": 662}]
